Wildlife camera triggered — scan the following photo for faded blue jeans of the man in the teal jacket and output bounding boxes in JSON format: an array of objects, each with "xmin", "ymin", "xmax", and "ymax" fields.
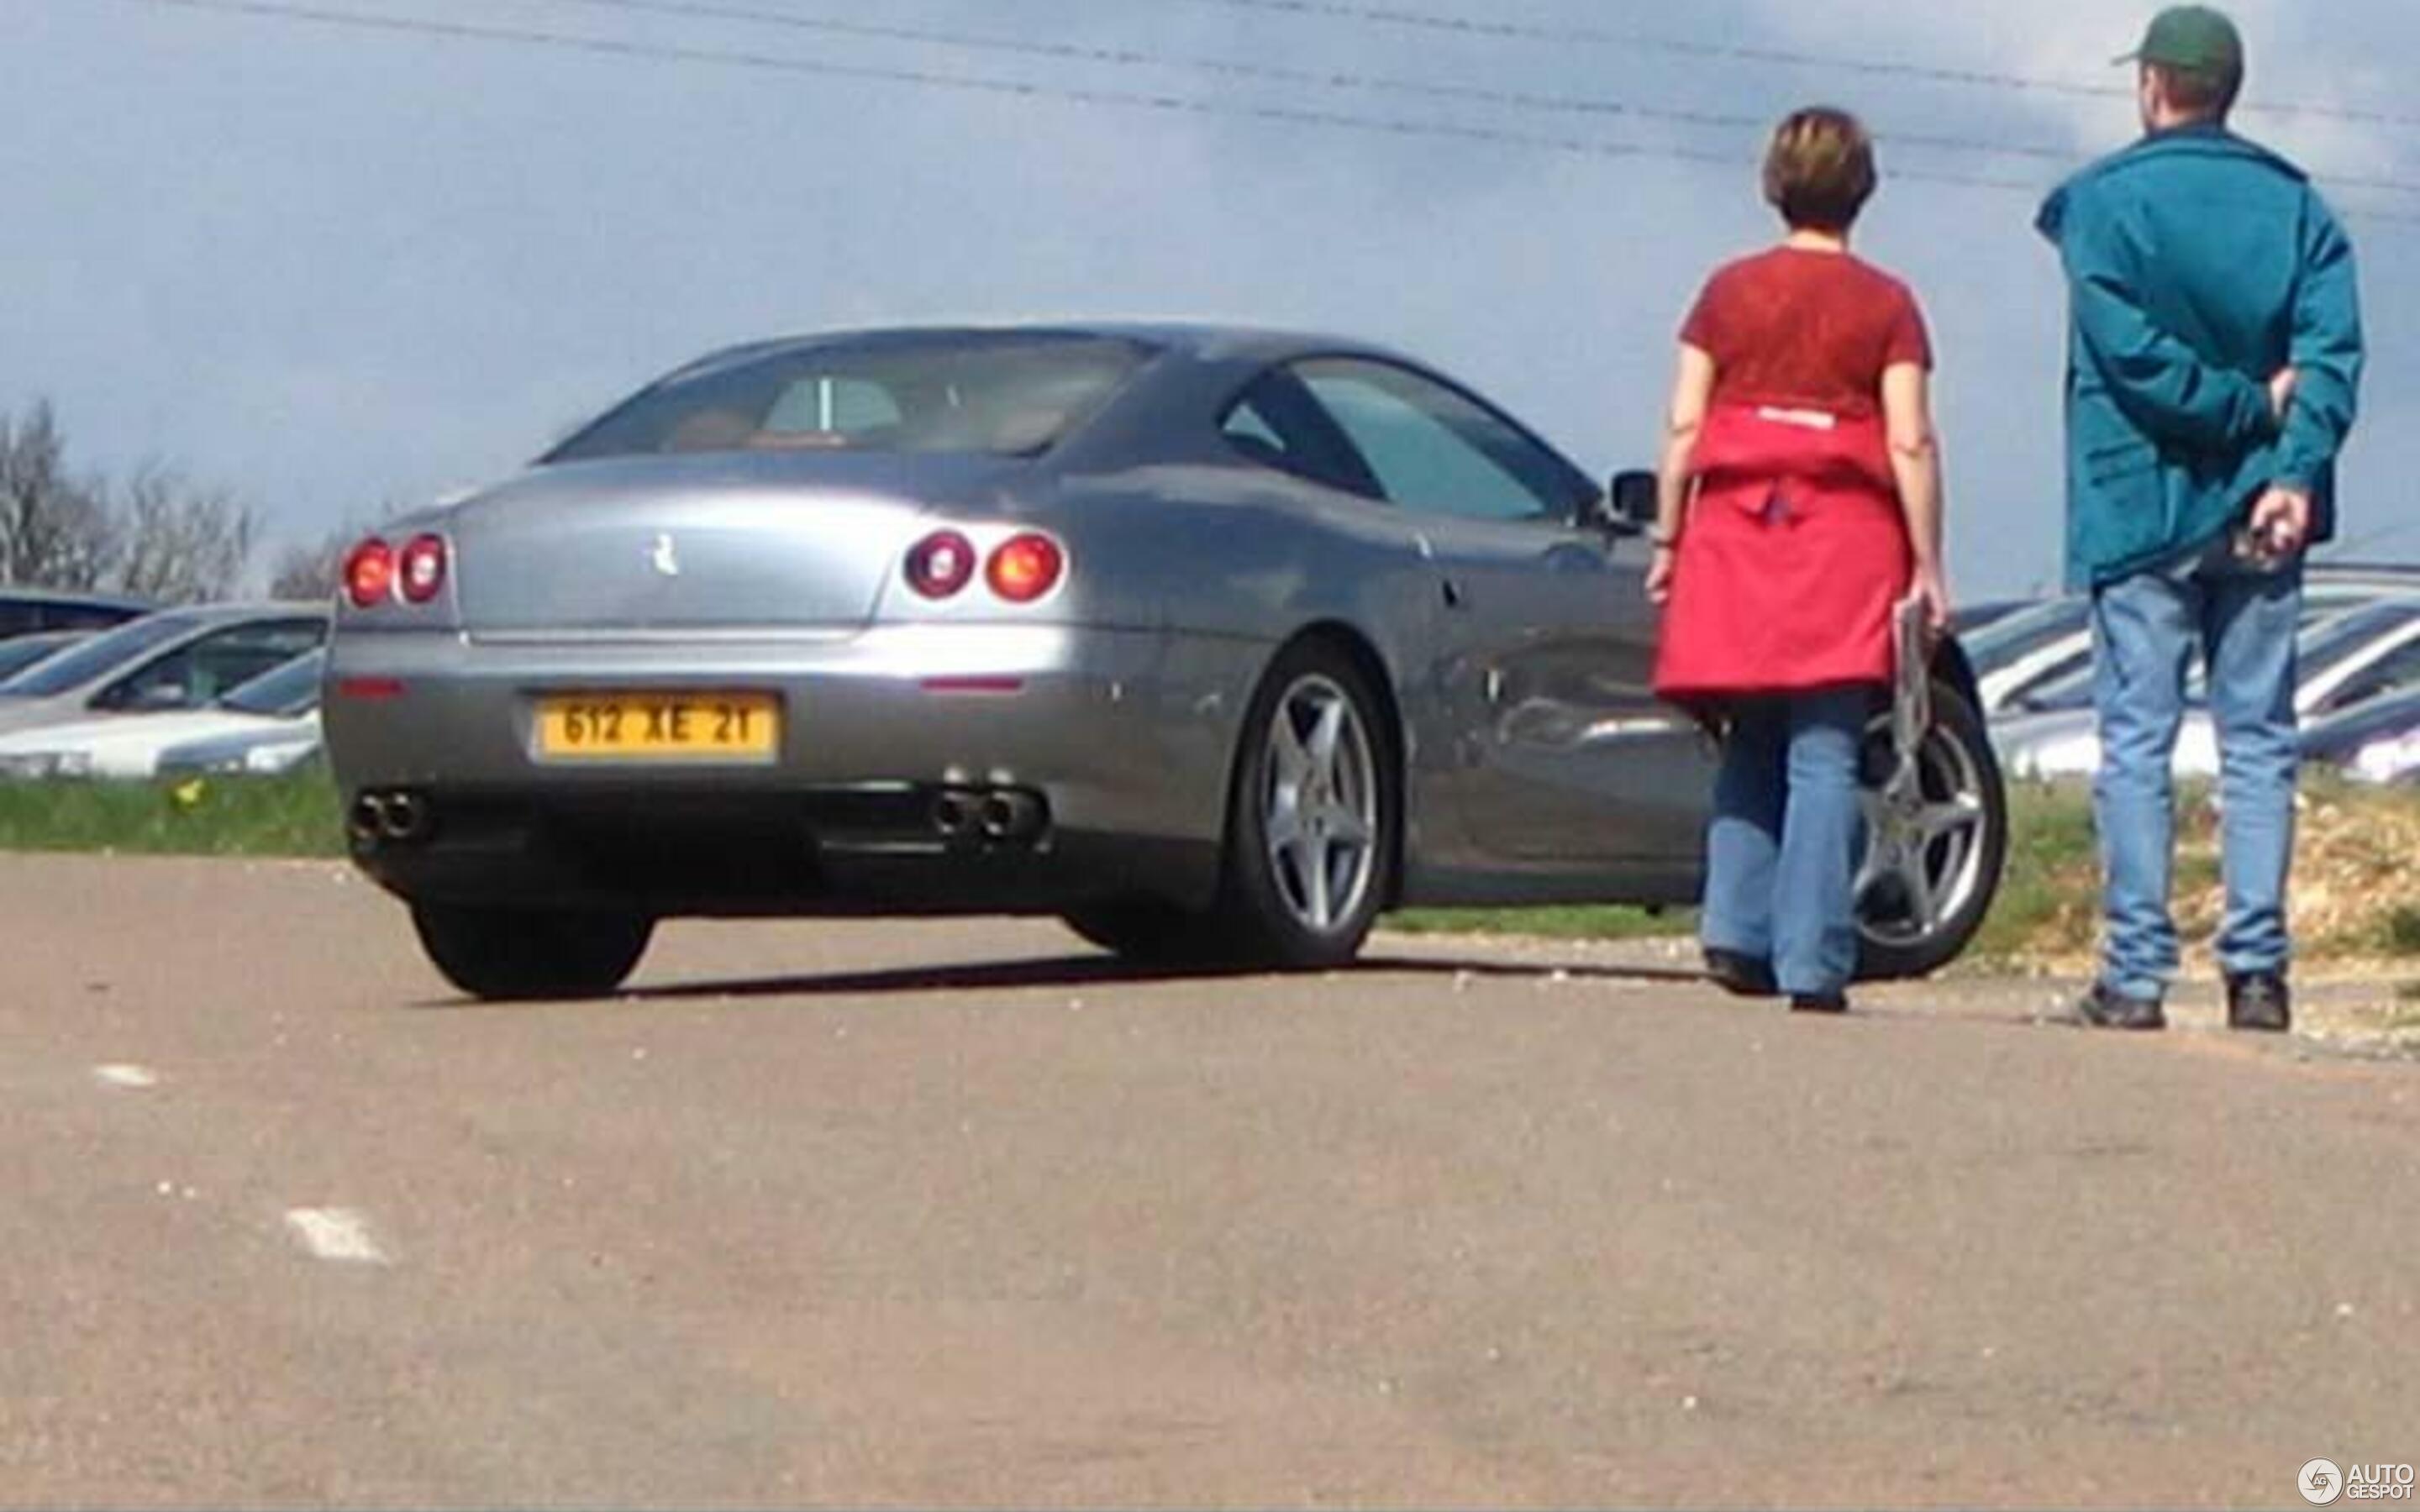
[{"xmin": 2093, "ymin": 552, "xmax": 2302, "ymax": 999}]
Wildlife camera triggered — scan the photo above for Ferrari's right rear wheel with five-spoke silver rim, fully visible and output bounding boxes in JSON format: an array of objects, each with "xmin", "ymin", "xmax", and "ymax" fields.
[{"xmin": 1202, "ymin": 641, "xmax": 1403, "ymax": 970}]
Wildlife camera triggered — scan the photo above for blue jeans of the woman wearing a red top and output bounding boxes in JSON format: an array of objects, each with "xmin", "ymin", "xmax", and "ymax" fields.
[{"xmin": 1702, "ymin": 687, "xmax": 1873, "ymax": 997}]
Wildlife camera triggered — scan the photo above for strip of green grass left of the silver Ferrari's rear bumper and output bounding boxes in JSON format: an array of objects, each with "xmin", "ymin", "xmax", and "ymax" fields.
[{"xmin": 0, "ymin": 769, "xmax": 344, "ymax": 857}]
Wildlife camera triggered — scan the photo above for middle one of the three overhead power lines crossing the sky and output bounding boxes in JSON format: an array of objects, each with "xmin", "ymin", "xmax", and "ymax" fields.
[{"xmin": 524, "ymin": 0, "xmax": 2420, "ymax": 196}]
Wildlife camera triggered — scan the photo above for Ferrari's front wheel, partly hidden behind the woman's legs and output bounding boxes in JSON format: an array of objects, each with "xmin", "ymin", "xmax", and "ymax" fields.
[{"xmin": 1856, "ymin": 680, "xmax": 2008, "ymax": 982}]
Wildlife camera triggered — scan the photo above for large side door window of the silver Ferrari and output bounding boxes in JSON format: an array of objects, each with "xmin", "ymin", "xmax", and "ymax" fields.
[{"xmin": 1297, "ymin": 358, "xmax": 1576, "ymax": 520}]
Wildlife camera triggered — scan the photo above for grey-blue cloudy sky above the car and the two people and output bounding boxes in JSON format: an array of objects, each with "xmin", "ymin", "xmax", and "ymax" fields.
[{"xmin": 13, "ymin": 0, "xmax": 2420, "ymax": 600}]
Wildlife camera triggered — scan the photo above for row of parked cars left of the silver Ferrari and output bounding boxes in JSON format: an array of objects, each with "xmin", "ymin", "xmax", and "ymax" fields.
[{"xmin": 0, "ymin": 588, "xmax": 329, "ymax": 779}]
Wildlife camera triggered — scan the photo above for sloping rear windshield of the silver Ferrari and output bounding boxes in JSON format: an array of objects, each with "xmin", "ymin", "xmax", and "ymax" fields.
[{"xmin": 544, "ymin": 333, "xmax": 1147, "ymax": 462}]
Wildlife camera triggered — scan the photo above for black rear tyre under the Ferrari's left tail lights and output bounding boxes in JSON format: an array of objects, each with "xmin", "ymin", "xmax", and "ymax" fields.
[{"xmin": 412, "ymin": 902, "xmax": 655, "ymax": 1001}]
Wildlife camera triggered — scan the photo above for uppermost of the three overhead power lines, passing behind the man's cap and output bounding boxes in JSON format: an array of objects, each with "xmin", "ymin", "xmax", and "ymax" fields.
[{"xmin": 1196, "ymin": 0, "xmax": 2420, "ymax": 126}]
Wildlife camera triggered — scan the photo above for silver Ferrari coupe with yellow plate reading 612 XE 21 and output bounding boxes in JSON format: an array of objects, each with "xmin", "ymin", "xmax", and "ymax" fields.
[{"xmin": 324, "ymin": 327, "xmax": 2007, "ymax": 997}]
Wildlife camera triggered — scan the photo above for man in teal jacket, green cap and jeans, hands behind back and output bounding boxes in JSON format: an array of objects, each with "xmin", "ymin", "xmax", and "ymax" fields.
[{"xmin": 2040, "ymin": 5, "xmax": 2362, "ymax": 1031}]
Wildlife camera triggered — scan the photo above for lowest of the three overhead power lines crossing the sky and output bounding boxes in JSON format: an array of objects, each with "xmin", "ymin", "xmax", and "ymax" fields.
[{"xmin": 103, "ymin": 0, "xmax": 2420, "ymax": 225}]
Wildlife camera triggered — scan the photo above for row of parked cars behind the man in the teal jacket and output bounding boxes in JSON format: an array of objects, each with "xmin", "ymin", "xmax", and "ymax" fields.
[{"xmin": 1963, "ymin": 566, "xmax": 2420, "ymax": 784}]
